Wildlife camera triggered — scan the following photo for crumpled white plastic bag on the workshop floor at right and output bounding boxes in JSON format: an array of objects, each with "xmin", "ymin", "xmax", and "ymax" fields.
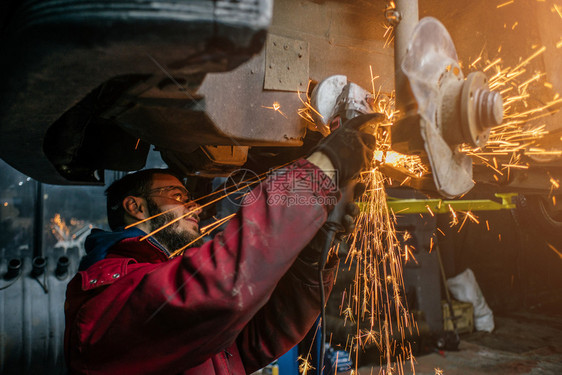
[{"xmin": 447, "ymin": 268, "xmax": 494, "ymax": 332}]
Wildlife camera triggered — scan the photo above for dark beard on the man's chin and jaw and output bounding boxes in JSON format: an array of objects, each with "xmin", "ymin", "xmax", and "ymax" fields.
[{"xmin": 147, "ymin": 198, "xmax": 204, "ymax": 253}]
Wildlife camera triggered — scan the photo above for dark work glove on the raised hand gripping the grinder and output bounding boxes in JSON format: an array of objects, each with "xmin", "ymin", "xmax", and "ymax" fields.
[{"xmin": 312, "ymin": 113, "xmax": 384, "ymax": 186}]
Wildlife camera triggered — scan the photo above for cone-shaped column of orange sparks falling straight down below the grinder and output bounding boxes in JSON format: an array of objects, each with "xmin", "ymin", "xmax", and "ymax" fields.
[{"xmin": 343, "ymin": 145, "xmax": 415, "ymax": 374}]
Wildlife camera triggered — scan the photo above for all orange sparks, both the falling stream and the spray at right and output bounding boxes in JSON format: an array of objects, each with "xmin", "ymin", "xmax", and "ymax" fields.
[{"xmin": 299, "ymin": 10, "xmax": 562, "ymax": 375}]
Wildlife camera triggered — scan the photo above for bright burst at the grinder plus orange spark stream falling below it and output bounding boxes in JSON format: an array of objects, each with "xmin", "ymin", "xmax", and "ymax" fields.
[{"xmin": 299, "ymin": 75, "xmax": 428, "ymax": 374}]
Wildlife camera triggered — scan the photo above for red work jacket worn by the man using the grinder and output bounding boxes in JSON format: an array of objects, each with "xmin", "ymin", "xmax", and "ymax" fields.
[{"xmin": 65, "ymin": 160, "xmax": 337, "ymax": 375}]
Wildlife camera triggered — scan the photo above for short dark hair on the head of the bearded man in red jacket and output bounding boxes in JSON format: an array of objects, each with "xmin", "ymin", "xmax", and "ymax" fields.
[{"xmin": 105, "ymin": 168, "xmax": 182, "ymax": 230}]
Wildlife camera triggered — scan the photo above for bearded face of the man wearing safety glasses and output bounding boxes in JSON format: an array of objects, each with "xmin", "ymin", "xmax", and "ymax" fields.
[{"xmin": 146, "ymin": 174, "xmax": 202, "ymax": 252}]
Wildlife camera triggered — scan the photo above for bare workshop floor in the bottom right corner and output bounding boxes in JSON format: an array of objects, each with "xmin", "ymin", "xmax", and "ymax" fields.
[{"xmin": 359, "ymin": 305, "xmax": 562, "ymax": 375}]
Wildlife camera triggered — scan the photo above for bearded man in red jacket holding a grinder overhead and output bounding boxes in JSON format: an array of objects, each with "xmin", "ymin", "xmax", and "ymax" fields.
[{"xmin": 65, "ymin": 116, "xmax": 374, "ymax": 375}]
